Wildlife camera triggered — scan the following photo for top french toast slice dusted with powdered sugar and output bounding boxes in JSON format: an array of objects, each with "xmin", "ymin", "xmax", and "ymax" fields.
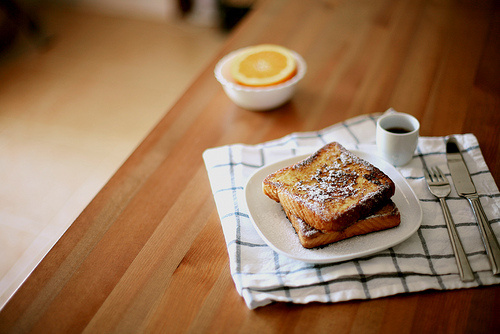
[{"xmin": 262, "ymin": 142, "xmax": 395, "ymax": 232}]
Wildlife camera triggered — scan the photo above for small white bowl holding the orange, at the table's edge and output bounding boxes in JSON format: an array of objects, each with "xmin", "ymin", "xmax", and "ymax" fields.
[{"xmin": 214, "ymin": 49, "xmax": 307, "ymax": 111}]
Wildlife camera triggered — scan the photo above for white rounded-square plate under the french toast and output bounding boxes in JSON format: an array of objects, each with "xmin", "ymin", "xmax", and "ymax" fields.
[{"xmin": 245, "ymin": 150, "xmax": 422, "ymax": 263}]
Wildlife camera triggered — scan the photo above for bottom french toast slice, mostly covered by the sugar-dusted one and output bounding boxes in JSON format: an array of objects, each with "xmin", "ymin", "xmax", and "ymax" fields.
[{"xmin": 285, "ymin": 201, "xmax": 401, "ymax": 248}]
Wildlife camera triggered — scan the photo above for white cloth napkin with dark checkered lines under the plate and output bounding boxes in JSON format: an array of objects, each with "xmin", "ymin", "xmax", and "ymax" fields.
[{"xmin": 203, "ymin": 110, "xmax": 500, "ymax": 309}]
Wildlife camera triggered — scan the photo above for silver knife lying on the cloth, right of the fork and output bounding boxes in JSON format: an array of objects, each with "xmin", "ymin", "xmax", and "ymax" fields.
[{"xmin": 446, "ymin": 137, "xmax": 500, "ymax": 275}]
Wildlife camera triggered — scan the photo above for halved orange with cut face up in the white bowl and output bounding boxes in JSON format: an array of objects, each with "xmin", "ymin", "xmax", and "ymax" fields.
[{"xmin": 231, "ymin": 44, "xmax": 297, "ymax": 87}]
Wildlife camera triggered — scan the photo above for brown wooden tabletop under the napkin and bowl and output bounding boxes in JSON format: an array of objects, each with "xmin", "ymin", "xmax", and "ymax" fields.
[{"xmin": 0, "ymin": 0, "xmax": 500, "ymax": 333}]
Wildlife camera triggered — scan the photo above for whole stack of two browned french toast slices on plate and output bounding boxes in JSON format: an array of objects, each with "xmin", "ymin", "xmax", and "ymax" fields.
[{"xmin": 263, "ymin": 142, "xmax": 401, "ymax": 248}]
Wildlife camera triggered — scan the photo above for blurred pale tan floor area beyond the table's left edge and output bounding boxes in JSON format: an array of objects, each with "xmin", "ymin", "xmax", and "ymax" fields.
[{"xmin": 0, "ymin": 0, "xmax": 256, "ymax": 308}]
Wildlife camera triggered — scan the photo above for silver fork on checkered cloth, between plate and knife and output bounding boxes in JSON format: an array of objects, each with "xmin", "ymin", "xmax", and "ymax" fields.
[{"xmin": 424, "ymin": 167, "xmax": 474, "ymax": 282}]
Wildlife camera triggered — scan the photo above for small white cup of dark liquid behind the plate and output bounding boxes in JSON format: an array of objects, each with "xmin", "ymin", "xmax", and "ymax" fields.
[{"xmin": 377, "ymin": 113, "xmax": 420, "ymax": 166}]
